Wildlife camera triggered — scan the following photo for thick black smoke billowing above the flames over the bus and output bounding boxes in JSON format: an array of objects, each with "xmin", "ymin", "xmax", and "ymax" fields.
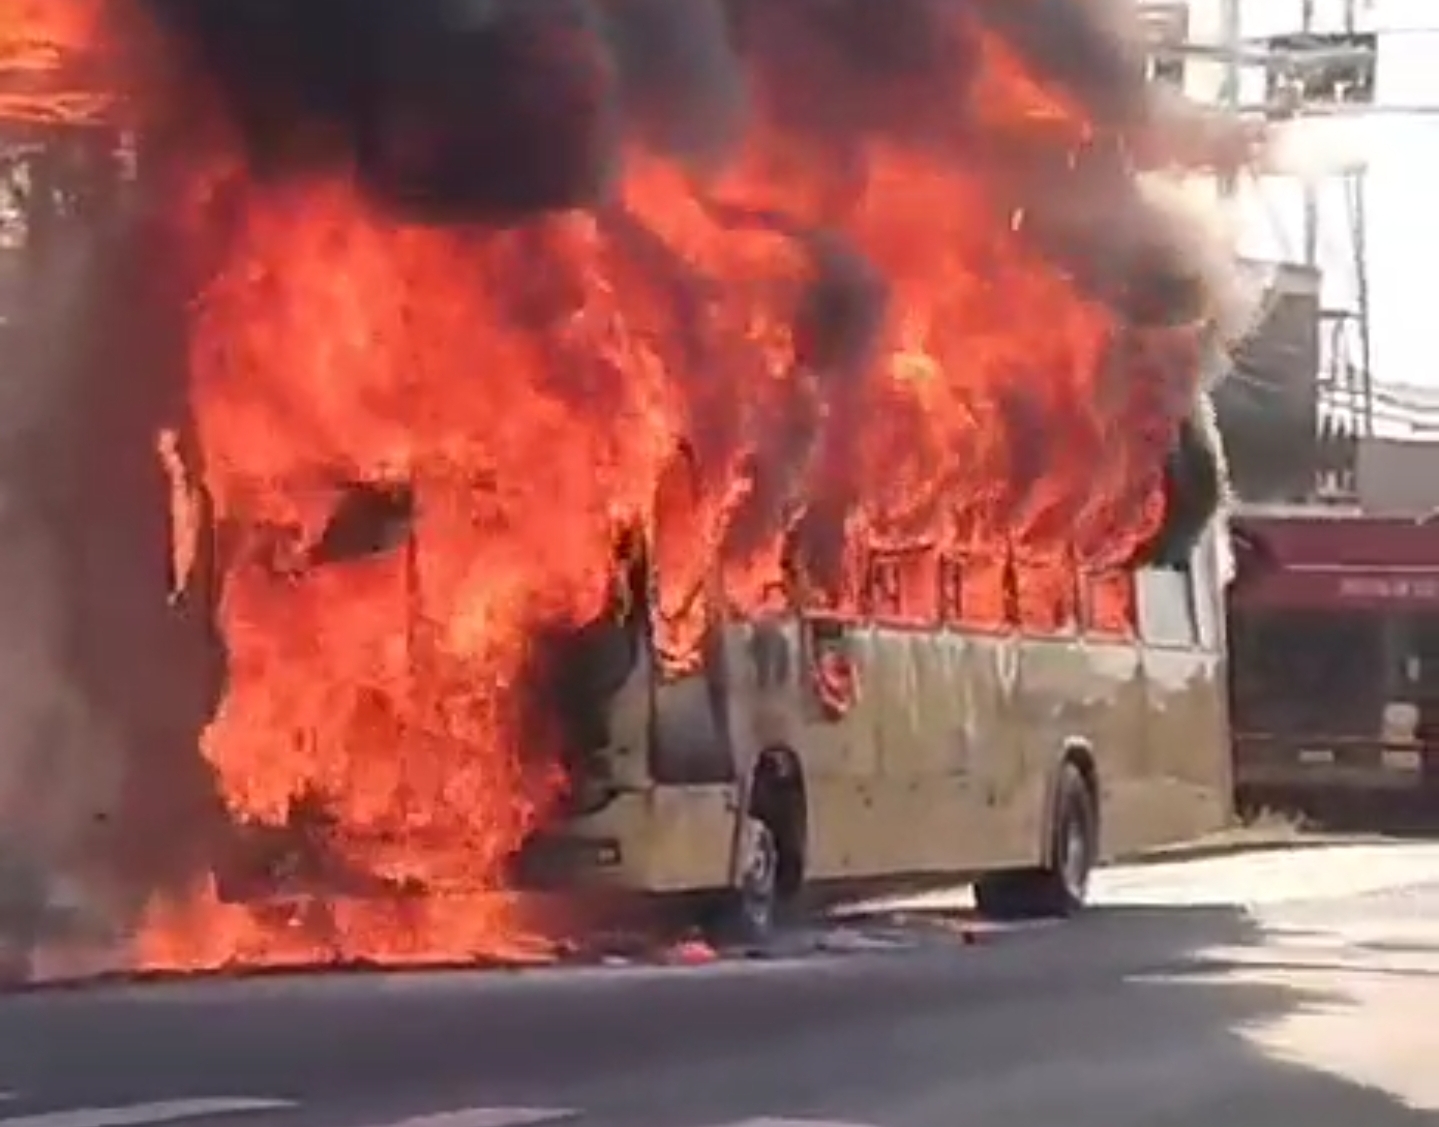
[{"xmin": 144, "ymin": 0, "xmax": 1256, "ymax": 572}]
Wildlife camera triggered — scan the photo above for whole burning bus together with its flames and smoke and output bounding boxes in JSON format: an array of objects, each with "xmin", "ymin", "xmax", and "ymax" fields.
[{"xmin": 0, "ymin": 0, "xmax": 1256, "ymax": 967}]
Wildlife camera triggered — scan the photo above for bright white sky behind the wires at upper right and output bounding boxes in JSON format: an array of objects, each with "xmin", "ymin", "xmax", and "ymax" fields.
[{"xmin": 1190, "ymin": 0, "xmax": 1439, "ymax": 410}]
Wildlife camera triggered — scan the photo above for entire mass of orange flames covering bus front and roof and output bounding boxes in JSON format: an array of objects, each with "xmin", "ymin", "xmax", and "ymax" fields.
[{"xmin": 0, "ymin": 0, "xmax": 1237, "ymax": 966}]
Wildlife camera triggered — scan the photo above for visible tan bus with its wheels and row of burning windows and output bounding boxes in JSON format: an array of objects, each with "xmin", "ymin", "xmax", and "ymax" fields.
[{"xmin": 519, "ymin": 463, "xmax": 1232, "ymax": 933}]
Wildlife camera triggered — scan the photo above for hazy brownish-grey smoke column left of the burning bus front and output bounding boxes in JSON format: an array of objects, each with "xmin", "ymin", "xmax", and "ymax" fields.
[{"xmin": 0, "ymin": 143, "xmax": 220, "ymax": 983}]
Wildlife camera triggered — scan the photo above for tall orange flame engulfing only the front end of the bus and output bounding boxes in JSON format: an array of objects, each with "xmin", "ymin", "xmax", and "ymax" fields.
[{"xmin": 137, "ymin": 181, "xmax": 676, "ymax": 959}]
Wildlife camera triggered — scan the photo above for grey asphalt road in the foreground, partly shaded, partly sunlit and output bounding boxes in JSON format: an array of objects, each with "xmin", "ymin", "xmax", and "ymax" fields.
[{"xmin": 0, "ymin": 846, "xmax": 1439, "ymax": 1127}]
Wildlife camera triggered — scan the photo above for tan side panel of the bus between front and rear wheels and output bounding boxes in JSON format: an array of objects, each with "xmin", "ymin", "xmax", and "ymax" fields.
[{"xmin": 731, "ymin": 620, "xmax": 1032, "ymax": 879}]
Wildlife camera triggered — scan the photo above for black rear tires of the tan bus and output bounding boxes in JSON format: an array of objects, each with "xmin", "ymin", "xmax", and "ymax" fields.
[{"xmin": 974, "ymin": 763, "xmax": 1099, "ymax": 920}]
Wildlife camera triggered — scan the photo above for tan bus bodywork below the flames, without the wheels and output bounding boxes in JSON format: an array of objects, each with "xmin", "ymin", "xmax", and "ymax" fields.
[{"xmin": 532, "ymin": 521, "xmax": 1232, "ymax": 915}]
